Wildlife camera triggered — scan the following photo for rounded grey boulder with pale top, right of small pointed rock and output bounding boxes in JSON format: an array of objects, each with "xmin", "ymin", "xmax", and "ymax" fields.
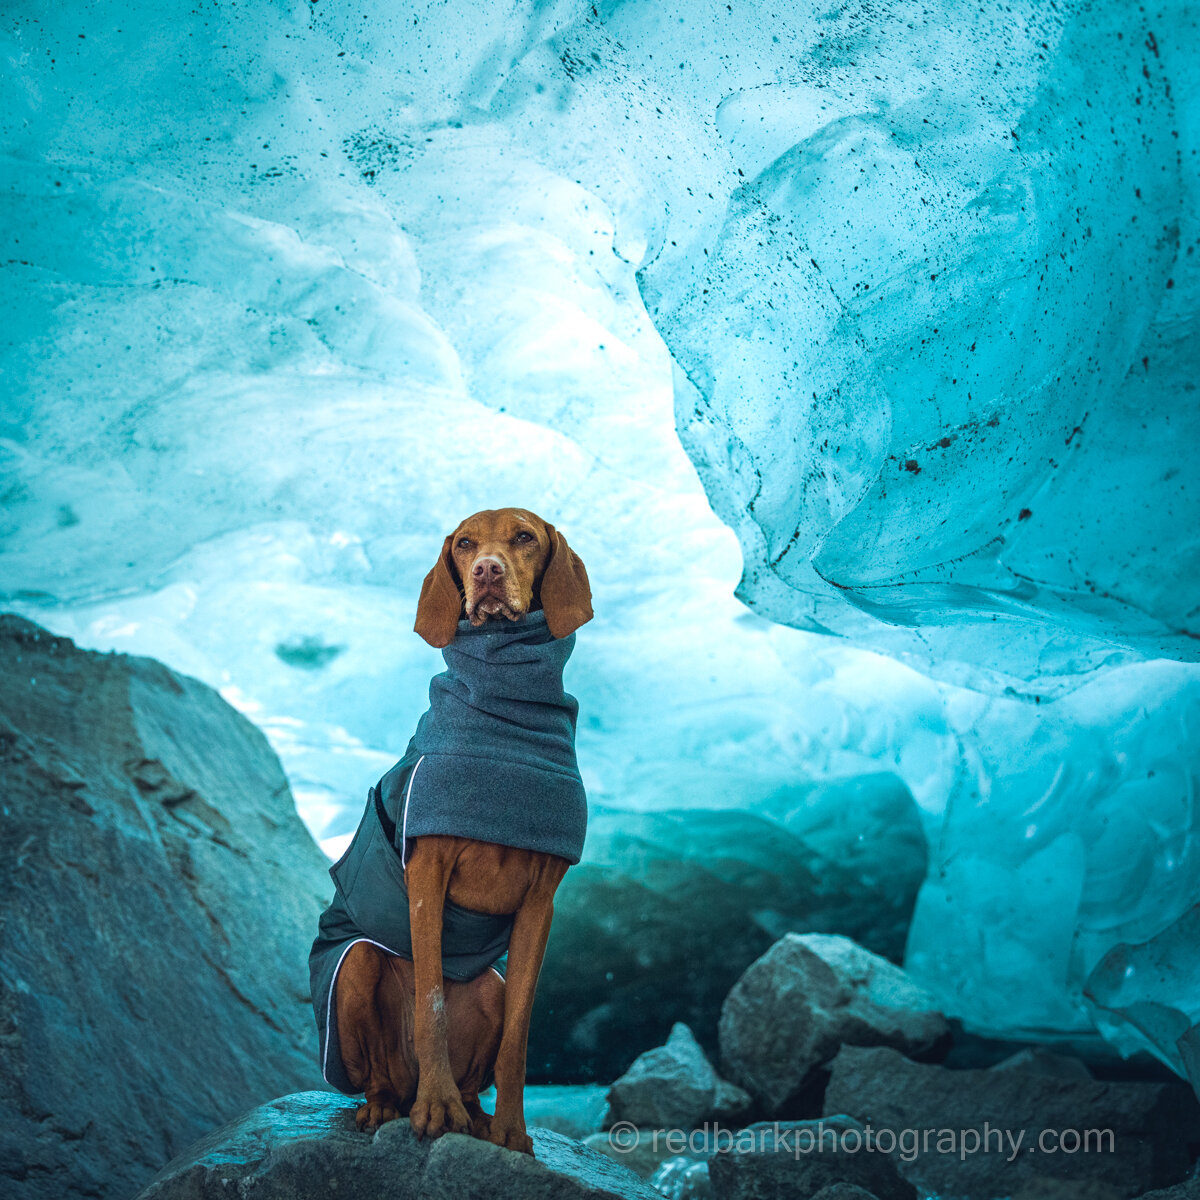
[{"xmin": 720, "ymin": 934, "xmax": 949, "ymax": 1112}]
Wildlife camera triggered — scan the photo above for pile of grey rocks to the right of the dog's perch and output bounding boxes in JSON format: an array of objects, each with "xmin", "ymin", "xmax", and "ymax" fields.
[{"xmin": 573, "ymin": 934, "xmax": 1200, "ymax": 1200}]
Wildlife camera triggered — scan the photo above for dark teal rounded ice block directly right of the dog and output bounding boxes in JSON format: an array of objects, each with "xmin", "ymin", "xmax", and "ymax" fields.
[{"xmin": 529, "ymin": 774, "xmax": 925, "ymax": 1082}]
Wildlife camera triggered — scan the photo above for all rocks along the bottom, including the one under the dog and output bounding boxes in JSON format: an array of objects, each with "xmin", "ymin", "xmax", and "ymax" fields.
[{"xmin": 126, "ymin": 854, "xmax": 1200, "ymax": 1200}]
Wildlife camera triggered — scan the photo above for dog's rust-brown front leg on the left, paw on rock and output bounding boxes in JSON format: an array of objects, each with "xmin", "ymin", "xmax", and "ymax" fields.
[{"xmin": 406, "ymin": 838, "xmax": 470, "ymax": 1138}]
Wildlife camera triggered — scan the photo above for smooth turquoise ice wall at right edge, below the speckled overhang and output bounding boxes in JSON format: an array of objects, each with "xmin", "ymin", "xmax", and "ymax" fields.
[{"xmin": 905, "ymin": 661, "xmax": 1200, "ymax": 1034}]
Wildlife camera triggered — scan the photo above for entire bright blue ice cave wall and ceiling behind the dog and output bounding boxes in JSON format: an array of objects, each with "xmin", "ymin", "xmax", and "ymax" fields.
[{"xmin": 0, "ymin": 0, "xmax": 1200, "ymax": 1084}]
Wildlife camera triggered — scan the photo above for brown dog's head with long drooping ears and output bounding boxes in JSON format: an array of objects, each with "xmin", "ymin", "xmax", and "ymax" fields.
[{"xmin": 415, "ymin": 509, "xmax": 592, "ymax": 649}]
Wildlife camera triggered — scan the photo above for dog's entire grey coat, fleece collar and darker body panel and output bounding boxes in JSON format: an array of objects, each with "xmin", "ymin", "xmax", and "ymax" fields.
[{"xmin": 308, "ymin": 612, "xmax": 587, "ymax": 1094}]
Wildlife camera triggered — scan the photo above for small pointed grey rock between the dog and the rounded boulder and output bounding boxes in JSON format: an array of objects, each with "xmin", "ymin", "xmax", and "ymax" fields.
[{"xmin": 606, "ymin": 1022, "xmax": 752, "ymax": 1129}]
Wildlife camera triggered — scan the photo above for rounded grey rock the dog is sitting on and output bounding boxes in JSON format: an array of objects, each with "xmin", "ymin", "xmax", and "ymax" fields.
[{"xmin": 138, "ymin": 1092, "xmax": 661, "ymax": 1200}]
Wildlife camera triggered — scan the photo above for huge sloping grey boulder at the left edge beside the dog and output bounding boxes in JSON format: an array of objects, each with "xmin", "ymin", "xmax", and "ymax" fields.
[{"xmin": 0, "ymin": 616, "xmax": 329, "ymax": 1200}]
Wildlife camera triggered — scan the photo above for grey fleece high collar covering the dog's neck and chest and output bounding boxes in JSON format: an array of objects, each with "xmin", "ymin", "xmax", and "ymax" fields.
[{"xmin": 397, "ymin": 612, "xmax": 587, "ymax": 863}]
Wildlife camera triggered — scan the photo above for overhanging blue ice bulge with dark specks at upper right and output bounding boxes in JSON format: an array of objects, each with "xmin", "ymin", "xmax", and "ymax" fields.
[{"xmin": 642, "ymin": 5, "xmax": 1200, "ymax": 695}]
